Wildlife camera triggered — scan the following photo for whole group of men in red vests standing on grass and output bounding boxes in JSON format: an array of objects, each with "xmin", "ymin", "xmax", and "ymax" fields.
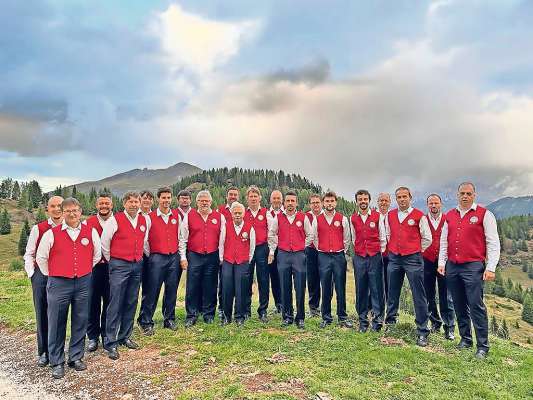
[{"xmin": 25, "ymin": 182, "xmax": 500, "ymax": 378}]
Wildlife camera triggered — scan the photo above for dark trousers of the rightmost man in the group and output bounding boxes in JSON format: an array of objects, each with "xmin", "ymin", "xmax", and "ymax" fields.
[{"xmin": 446, "ymin": 261, "xmax": 489, "ymax": 351}]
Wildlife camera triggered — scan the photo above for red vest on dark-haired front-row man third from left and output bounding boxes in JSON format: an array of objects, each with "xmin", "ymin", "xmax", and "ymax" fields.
[{"xmin": 148, "ymin": 210, "xmax": 179, "ymax": 254}]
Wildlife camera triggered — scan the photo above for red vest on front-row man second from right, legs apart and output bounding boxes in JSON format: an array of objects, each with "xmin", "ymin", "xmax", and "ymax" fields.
[{"xmin": 387, "ymin": 208, "xmax": 424, "ymax": 256}]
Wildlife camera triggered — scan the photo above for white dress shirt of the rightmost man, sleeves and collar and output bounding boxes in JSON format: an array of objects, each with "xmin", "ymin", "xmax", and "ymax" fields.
[{"xmin": 439, "ymin": 203, "xmax": 500, "ymax": 272}]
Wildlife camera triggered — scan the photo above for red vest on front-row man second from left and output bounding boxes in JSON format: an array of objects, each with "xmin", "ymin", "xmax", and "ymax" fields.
[{"xmin": 110, "ymin": 212, "xmax": 146, "ymax": 262}]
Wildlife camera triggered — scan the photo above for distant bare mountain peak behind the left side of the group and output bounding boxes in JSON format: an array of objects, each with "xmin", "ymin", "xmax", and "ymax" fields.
[{"xmin": 70, "ymin": 162, "xmax": 202, "ymax": 196}]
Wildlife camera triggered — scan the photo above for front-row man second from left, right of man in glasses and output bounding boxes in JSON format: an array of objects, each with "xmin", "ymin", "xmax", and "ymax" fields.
[{"xmin": 98, "ymin": 192, "xmax": 148, "ymax": 360}]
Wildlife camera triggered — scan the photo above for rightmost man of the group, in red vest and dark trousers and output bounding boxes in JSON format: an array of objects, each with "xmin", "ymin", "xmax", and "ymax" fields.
[{"xmin": 438, "ymin": 182, "xmax": 500, "ymax": 359}]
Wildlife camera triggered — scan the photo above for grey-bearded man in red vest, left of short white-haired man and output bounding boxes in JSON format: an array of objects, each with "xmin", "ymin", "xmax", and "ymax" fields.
[{"xmin": 179, "ymin": 190, "xmax": 226, "ymax": 328}]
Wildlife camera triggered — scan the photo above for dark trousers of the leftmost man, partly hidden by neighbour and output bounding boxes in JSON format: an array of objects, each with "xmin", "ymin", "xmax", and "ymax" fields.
[{"xmin": 31, "ymin": 266, "xmax": 48, "ymax": 356}]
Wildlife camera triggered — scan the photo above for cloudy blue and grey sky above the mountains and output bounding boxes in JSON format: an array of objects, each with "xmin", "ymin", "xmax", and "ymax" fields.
[{"xmin": 0, "ymin": 0, "xmax": 533, "ymax": 198}]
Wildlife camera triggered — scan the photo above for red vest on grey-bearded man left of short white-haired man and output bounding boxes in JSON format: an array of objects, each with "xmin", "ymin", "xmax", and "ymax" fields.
[{"xmin": 187, "ymin": 210, "xmax": 222, "ymax": 254}]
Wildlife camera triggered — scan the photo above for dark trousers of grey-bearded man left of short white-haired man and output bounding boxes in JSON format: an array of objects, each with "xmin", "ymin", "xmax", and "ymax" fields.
[{"xmin": 185, "ymin": 250, "xmax": 220, "ymax": 320}]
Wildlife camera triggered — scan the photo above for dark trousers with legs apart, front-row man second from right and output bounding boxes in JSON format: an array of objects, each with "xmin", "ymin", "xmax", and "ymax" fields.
[{"xmin": 385, "ymin": 253, "xmax": 429, "ymax": 336}]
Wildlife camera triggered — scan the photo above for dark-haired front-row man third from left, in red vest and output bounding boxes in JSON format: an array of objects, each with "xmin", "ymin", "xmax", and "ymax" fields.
[{"xmin": 137, "ymin": 186, "xmax": 181, "ymax": 336}]
